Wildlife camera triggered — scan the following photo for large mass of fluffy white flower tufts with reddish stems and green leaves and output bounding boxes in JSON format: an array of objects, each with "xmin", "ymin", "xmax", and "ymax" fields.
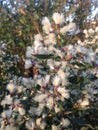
[{"xmin": 0, "ymin": 13, "xmax": 98, "ymax": 130}]
